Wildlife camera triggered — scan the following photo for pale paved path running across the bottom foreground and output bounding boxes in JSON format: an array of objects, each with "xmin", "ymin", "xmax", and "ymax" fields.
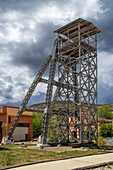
[{"xmin": 11, "ymin": 153, "xmax": 113, "ymax": 170}]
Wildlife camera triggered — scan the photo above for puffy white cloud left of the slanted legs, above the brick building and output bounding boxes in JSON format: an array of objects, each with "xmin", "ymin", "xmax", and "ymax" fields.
[{"xmin": 0, "ymin": 66, "xmax": 31, "ymax": 104}]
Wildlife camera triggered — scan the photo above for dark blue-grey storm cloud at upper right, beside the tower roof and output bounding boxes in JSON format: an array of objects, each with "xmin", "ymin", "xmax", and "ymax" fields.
[{"xmin": 96, "ymin": 0, "xmax": 113, "ymax": 53}]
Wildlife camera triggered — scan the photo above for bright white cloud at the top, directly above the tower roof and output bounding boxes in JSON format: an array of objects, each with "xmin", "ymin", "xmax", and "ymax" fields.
[{"xmin": 35, "ymin": 0, "xmax": 106, "ymax": 25}]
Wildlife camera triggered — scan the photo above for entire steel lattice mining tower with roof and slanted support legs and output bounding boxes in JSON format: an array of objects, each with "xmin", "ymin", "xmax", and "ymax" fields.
[{"xmin": 7, "ymin": 18, "xmax": 100, "ymax": 144}]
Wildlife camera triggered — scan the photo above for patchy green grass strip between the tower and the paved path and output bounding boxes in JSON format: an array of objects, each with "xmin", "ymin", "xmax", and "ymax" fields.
[{"xmin": 0, "ymin": 144, "xmax": 109, "ymax": 168}]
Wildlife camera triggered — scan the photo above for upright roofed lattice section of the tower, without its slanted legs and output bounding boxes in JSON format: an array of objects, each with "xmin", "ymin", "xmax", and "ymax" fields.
[{"xmin": 54, "ymin": 18, "xmax": 101, "ymax": 143}]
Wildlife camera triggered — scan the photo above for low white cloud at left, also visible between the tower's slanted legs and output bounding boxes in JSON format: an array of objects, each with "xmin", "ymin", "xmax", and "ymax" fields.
[{"xmin": 0, "ymin": 63, "xmax": 47, "ymax": 105}]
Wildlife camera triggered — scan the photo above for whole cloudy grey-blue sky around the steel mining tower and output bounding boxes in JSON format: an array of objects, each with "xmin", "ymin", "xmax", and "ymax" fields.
[{"xmin": 0, "ymin": 0, "xmax": 113, "ymax": 106}]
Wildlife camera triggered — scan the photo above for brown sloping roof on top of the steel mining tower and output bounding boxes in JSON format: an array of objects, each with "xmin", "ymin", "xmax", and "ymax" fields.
[{"xmin": 54, "ymin": 18, "xmax": 101, "ymax": 38}]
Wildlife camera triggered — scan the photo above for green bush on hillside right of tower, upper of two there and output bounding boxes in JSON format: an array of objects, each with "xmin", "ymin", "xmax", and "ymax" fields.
[{"xmin": 98, "ymin": 106, "xmax": 113, "ymax": 119}]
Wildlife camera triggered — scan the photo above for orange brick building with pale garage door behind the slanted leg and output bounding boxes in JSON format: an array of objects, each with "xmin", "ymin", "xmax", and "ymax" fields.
[{"xmin": 0, "ymin": 105, "xmax": 33, "ymax": 142}]
